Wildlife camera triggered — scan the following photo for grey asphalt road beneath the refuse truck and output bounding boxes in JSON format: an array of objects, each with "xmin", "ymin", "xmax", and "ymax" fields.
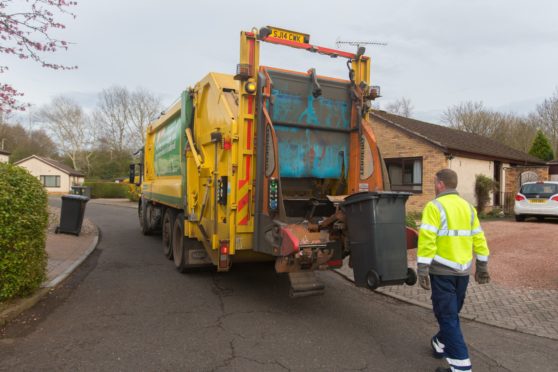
[{"xmin": 0, "ymin": 204, "xmax": 558, "ymax": 371}]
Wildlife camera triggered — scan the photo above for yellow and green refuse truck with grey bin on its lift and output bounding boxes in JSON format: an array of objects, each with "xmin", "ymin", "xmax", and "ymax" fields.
[{"xmin": 130, "ymin": 27, "xmax": 416, "ymax": 297}]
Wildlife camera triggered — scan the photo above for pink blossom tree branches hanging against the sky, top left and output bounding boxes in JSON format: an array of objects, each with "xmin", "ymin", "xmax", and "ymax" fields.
[{"xmin": 0, "ymin": 0, "xmax": 77, "ymax": 113}]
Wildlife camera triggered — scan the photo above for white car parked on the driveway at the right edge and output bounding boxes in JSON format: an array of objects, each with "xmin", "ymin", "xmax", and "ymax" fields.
[{"xmin": 513, "ymin": 181, "xmax": 558, "ymax": 221}]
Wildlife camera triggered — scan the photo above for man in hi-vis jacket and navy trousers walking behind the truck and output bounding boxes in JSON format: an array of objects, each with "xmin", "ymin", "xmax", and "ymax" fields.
[{"xmin": 417, "ymin": 169, "xmax": 490, "ymax": 372}]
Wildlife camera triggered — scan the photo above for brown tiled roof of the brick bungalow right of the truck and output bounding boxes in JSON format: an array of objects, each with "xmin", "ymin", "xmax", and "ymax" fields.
[{"xmin": 371, "ymin": 110, "xmax": 545, "ymax": 165}]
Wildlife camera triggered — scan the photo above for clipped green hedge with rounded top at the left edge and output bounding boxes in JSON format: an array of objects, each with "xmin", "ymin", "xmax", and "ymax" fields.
[{"xmin": 0, "ymin": 163, "xmax": 48, "ymax": 301}]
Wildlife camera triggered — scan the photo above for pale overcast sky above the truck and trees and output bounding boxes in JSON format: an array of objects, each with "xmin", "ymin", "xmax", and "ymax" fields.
[{"xmin": 2, "ymin": 0, "xmax": 558, "ymax": 123}]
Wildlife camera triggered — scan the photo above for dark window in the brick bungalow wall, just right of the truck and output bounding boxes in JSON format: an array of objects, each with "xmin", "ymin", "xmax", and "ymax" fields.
[{"xmin": 385, "ymin": 158, "xmax": 422, "ymax": 193}]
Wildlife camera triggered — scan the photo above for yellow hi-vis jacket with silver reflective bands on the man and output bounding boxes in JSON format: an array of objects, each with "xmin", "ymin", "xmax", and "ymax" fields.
[{"xmin": 417, "ymin": 192, "xmax": 489, "ymax": 275}]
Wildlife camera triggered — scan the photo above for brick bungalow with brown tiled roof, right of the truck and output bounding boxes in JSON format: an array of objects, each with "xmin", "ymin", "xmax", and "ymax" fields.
[{"xmin": 370, "ymin": 110, "xmax": 549, "ymax": 212}]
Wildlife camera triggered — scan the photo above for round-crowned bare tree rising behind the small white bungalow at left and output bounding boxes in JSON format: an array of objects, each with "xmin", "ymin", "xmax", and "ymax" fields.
[{"xmin": 37, "ymin": 96, "xmax": 94, "ymax": 170}]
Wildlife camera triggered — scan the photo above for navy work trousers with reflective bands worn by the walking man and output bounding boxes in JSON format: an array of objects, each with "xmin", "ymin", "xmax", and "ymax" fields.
[{"xmin": 430, "ymin": 275, "xmax": 471, "ymax": 371}]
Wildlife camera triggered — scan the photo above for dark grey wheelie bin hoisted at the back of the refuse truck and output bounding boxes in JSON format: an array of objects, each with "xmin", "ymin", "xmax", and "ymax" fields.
[{"xmin": 342, "ymin": 191, "xmax": 416, "ymax": 289}]
